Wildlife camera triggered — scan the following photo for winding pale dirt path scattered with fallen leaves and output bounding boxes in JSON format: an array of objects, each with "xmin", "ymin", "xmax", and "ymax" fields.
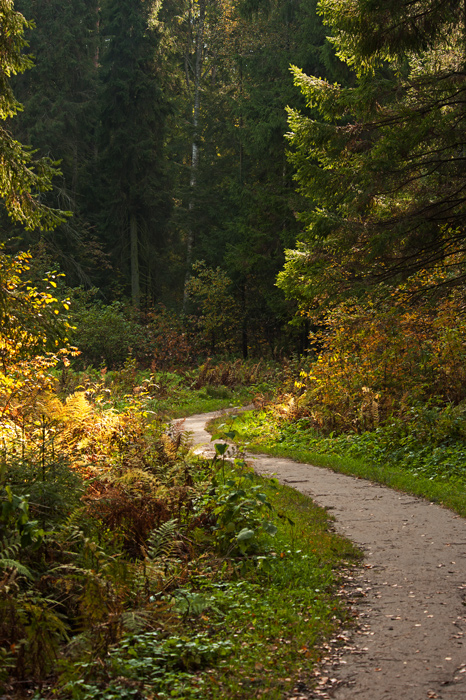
[{"xmin": 184, "ymin": 413, "xmax": 466, "ymax": 700}]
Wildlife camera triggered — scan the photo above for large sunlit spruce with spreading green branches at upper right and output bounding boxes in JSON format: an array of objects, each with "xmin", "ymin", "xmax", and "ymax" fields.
[{"xmin": 279, "ymin": 0, "xmax": 466, "ymax": 304}]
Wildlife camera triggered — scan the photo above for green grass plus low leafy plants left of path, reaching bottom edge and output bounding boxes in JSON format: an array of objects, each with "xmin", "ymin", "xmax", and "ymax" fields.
[{"xmin": 59, "ymin": 467, "xmax": 361, "ymax": 700}]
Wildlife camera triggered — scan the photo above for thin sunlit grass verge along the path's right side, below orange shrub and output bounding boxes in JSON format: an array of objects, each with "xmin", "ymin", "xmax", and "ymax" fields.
[{"xmin": 210, "ymin": 412, "xmax": 466, "ymax": 517}]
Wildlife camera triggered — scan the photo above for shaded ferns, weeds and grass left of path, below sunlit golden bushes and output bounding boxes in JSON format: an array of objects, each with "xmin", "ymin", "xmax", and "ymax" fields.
[{"xmin": 0, "ymin": 422, "xmax": 358, "ymax": 700}]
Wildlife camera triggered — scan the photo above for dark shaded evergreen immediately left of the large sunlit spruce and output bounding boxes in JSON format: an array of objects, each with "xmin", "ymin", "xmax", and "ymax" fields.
[{"xmin": 220, "ymin": 0, "xmax": 333, "ymax": 352}]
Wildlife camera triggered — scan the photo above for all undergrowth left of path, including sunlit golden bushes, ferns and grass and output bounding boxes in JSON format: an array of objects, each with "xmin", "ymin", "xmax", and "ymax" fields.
[{"xmin": 0, "ymin": 278, "xmax": 357, "ymax": 700}]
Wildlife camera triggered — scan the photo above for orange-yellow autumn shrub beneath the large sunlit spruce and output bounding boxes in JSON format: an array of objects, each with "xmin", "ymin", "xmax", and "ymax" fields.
[{"xmin": 294, "ymin": 284, "xmax": 466, "ymax": 432}]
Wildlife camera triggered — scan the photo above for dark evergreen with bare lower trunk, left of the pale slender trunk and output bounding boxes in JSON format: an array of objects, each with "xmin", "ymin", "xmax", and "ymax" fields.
[{"xmin": 96, "ymin": 0, "xmax": 170, "ymax": 306}]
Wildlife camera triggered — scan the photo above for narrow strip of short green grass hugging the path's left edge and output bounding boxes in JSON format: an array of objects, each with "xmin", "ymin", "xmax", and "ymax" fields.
[{"xmin": 197, "ymin": 484, "xmax": 360, "ymax": 700}]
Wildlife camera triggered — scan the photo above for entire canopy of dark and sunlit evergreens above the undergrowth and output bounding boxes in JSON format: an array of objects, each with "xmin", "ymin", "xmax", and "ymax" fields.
[{"xmin": 7, "ymin": 0, "xmax": 466, "ymax": 348}]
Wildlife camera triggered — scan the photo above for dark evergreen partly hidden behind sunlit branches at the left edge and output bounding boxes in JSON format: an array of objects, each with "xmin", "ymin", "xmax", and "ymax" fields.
[{"xmin": 5, "ymin": 0, "xmax": 98, "ymax": 282}]
